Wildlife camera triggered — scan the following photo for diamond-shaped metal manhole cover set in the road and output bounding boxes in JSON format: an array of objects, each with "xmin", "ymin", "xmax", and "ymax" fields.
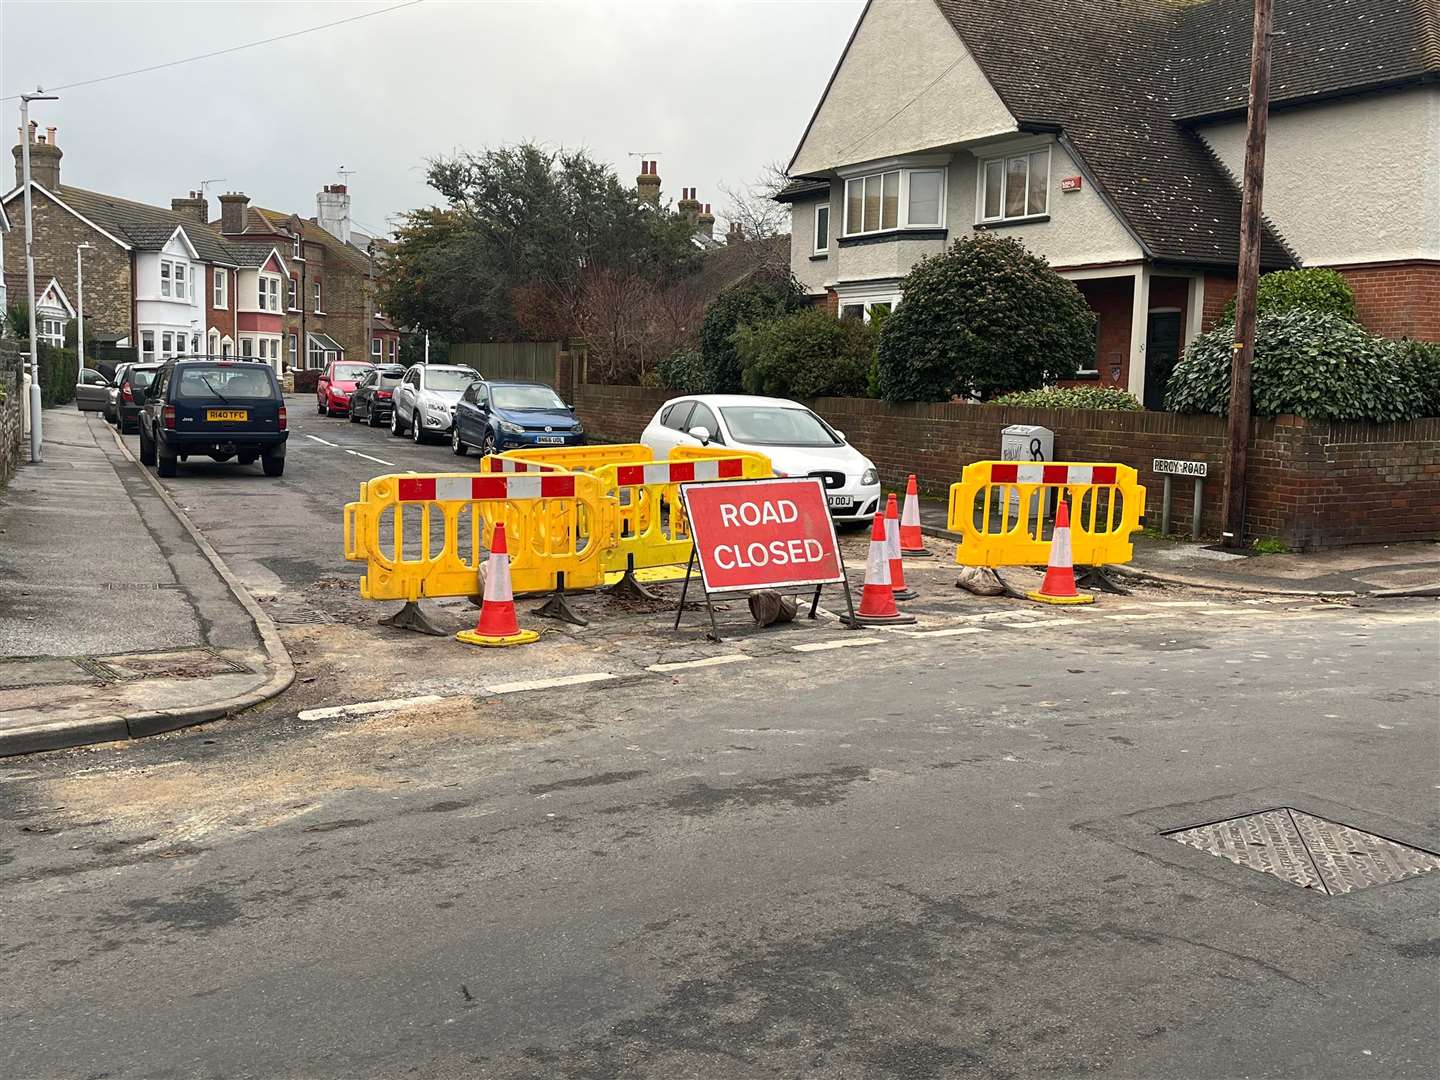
[{"xmin": 1164, "ymin": 806, "xmax": 1440, "ymax": 896}]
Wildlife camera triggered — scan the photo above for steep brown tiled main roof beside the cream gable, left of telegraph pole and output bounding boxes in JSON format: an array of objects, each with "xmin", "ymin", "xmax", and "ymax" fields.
[{"xmin": 935, "ymin": 0, "xmax": 1307, "ymax": 266}]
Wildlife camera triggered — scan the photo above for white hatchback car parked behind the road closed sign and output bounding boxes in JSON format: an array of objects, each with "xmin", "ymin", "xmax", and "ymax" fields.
[{"xmin": 639, "ymin": 393, "xmax": 881, "ymax": 524}]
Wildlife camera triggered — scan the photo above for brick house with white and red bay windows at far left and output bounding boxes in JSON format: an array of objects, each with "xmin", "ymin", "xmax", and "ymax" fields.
[{"xmin": 0, "ymin": 124, "xmax": 298, "ymax": 372}]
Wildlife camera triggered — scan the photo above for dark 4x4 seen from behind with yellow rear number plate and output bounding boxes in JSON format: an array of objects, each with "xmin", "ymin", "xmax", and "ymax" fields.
[{"xmin": 140, "ymin": 360, "xmax": 289, "ymax": 477}]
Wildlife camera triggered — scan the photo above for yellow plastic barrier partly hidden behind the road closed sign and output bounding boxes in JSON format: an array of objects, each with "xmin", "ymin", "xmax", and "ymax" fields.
[{"xmin": 595, "ymin": 448, "xmax": 772, "ymax": 572}]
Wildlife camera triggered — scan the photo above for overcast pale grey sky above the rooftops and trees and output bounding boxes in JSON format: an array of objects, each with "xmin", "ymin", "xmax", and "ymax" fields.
[{"xmin": 0, "ymin": 0, "xmax": 863, "ymax": 236}]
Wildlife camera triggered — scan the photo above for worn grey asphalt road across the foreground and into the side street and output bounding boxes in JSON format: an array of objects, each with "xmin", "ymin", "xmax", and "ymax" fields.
[{"xmin": 0, "ymin": 409, "xmax": 1440, "ymax": 1080}]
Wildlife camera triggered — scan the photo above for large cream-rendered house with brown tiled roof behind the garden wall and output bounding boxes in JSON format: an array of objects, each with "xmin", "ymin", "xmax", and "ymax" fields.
[{"xmin": 779, "ymin": 0, "xmax": 1440, "ymax": 408}]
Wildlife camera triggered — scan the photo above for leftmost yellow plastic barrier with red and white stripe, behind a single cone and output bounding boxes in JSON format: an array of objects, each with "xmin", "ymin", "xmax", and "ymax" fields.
[{"xmin": 344, "ymin": 472, "xmax": 616, "ymax": 600}]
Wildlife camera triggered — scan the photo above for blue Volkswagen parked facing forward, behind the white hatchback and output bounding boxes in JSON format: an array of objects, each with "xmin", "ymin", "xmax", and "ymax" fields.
[{"xmin": 451, "ymin": 379, "xmax": 585, "ymax": 458}]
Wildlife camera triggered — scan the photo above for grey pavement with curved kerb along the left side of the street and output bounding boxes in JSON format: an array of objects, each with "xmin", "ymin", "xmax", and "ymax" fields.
[{"xmin": 0, "ymin": 409, "xmax": 291, "ymax": 755}]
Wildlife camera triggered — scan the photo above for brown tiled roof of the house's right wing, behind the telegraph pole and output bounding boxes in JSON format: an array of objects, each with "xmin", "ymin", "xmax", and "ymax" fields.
[{"xmin": 1175, "ymin": 0, "xmax": 1440, "ymax": 117}]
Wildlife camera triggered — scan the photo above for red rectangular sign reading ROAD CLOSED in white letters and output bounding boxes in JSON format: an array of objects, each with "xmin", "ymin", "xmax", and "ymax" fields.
[{"xmin": 680, "ymin": 477, "xmax": 845, "ymax": 592}]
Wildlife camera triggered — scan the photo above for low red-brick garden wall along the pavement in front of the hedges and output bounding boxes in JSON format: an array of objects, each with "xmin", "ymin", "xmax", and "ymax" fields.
[{"xmin": 575, "ymin": 384, "xmax": 1440, "ymax": 549}]
